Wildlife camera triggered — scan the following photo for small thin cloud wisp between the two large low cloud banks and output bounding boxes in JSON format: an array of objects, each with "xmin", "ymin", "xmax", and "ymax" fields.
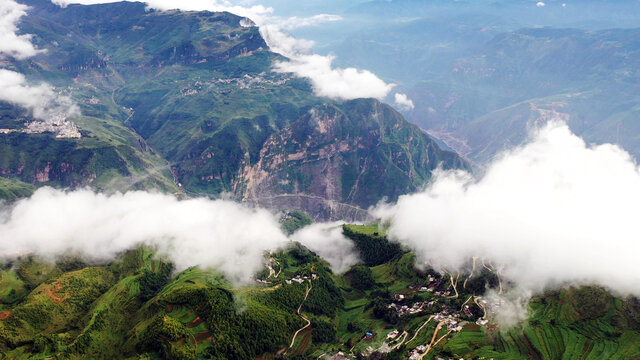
[{"xmin": 291, "ymin": 222, "xmax": 360, "ymax": 274}]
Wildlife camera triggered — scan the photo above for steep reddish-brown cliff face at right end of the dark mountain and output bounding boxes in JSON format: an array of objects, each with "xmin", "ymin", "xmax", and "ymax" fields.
[{"xmin": 236, "ymin": 99, "xmax": 466, "ymax": 219}]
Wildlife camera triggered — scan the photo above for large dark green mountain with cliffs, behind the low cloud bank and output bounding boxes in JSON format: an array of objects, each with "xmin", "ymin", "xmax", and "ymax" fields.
[{"xmin": 0, "ymin": 0, "xmax": 467, "ymax": 218}]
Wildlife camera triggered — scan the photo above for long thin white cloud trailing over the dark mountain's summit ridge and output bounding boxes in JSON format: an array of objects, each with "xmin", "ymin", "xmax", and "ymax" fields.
[{"xmin": 53, "ymin": 0, "xmax": 395, "ymax": 100}]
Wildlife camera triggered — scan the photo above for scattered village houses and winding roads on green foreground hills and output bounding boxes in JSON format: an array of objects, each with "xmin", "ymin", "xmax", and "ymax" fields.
[{"xmin": 256, "ymin": 253, "xmax": 504, "ymax": 360}]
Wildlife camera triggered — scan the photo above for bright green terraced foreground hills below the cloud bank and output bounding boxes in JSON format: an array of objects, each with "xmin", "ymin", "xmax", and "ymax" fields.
[{"xmin": 0, "ymin": 225, "xmax": 640, "ymax": 360}]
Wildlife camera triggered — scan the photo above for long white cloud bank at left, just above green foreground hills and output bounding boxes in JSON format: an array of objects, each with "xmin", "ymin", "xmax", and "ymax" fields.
[{"xmin": 0, "ymin": 188, "xmax": 288, "ymax": 281}]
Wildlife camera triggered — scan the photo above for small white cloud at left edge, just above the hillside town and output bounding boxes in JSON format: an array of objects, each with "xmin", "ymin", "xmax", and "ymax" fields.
[{"xmin": 0, "ymin": 69, "xmax": 79, "ymax": 122}]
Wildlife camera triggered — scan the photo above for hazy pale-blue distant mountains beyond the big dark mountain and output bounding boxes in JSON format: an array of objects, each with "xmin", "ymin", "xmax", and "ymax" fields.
[{"xmin": 286, "ymin": 0, "xmax": 640, "ymax": 165}]
